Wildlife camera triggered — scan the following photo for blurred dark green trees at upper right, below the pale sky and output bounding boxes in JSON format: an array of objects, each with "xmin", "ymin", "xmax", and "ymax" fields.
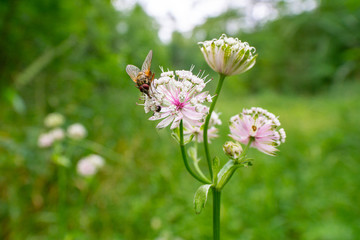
[{"xmin": 190, "ymin": 0, "xmax": 360, "ymax": 93}]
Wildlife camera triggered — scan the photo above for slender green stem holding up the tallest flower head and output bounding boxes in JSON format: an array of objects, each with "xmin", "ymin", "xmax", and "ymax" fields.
[{"xmin": 204, "ymin": 74, "xmax": 226, "ymax": 179}]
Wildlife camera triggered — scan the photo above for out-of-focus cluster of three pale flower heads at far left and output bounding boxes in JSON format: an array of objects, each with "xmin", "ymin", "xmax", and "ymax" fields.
[{"xmin": 38, "ymin": 113, "xmax": 87, "ymax": 148}]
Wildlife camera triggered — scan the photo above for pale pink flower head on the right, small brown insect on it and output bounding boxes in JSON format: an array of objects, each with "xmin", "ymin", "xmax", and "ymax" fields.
[{"xmin": 229, "ymin": 107, "xmax": 286, "ymax": 155}]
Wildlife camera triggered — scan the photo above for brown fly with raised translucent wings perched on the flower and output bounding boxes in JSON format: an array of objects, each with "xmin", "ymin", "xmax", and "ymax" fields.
[{"xmin": 126, "ymin": 50, "xmax": 155, "ymax": 98}]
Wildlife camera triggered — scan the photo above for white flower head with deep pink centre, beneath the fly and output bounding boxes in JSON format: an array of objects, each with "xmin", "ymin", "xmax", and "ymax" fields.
[{"xmin": 144, "ymin": 70, "xmax": 211, "ymax": 129}]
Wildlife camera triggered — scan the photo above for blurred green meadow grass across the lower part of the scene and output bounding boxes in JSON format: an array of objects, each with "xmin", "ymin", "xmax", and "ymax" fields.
[{"xmin": 0, "ymin": 82, "xmax": 360, "ymax": 240}]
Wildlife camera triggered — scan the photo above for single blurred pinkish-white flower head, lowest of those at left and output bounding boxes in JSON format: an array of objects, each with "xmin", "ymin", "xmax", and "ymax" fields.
[{"xmin": 76, "ymin": 154, "xmax": 105, "ymax": 176}]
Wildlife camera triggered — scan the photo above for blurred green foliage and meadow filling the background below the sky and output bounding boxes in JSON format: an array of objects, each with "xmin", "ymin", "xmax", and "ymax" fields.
[{"xmin": 0, "ymin": 0, "xmax": 360, "ymax": 240}]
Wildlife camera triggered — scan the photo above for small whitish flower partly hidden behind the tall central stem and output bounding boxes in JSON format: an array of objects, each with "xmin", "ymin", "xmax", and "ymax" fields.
[{"xmin": 185, "ymin": 112, "xmax": 222, "ymax": 143}]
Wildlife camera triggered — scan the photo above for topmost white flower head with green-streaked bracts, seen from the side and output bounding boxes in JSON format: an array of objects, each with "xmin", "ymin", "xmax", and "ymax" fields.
[{"xmin": 198, "ymin": 34, "xmax": 257, "ymax": 76}]
